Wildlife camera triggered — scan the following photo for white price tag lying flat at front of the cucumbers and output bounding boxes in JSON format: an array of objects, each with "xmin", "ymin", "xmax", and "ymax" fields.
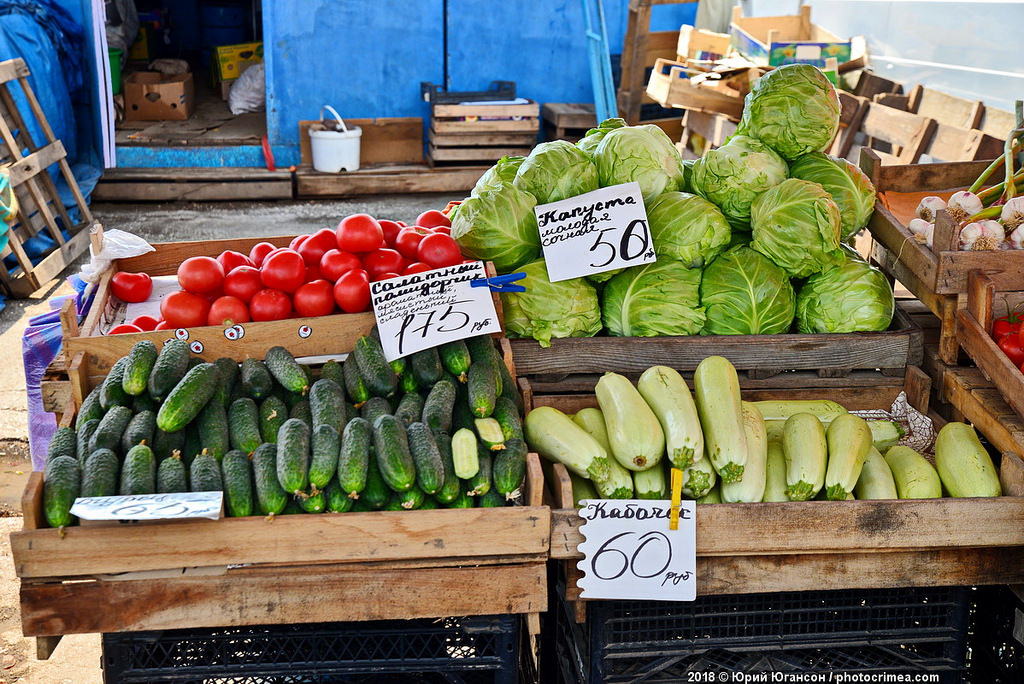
[{"xmin": 71, "ymin": 491, "xmax": 224, "ymax": 520}]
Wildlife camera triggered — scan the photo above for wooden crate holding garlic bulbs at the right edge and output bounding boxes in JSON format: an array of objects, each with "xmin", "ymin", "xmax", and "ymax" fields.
[{"xmin": 860, "ymin": 149, "xmax": 1024, "ymax": 366}]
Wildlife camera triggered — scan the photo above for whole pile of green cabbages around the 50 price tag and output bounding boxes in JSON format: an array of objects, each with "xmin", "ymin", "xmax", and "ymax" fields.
[{"xmin": 452, "ymin": 65, "xmax": 894, "ymax": 346}]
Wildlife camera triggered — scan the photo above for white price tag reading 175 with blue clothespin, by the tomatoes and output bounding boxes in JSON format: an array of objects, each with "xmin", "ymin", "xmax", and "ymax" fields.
[{"xmin": 370, "ymin": 261, "xmax": 501, "ymax": 361}]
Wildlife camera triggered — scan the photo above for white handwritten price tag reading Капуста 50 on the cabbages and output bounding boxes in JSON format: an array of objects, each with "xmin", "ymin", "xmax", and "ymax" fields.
[{"xmin": 534, "ymin": 182, "xmax": 657, "ymax": 283}]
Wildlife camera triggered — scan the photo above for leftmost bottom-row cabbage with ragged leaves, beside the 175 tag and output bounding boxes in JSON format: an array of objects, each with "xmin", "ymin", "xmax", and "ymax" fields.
[{"xmin": 501, "ymin": 259, "xmax": 601, "ymax": 347}]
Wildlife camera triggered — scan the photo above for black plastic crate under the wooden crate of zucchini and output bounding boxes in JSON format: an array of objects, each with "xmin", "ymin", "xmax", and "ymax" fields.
[{"xmin": 556, "ymin": 587, "xmax": 971, "ymax": 684}]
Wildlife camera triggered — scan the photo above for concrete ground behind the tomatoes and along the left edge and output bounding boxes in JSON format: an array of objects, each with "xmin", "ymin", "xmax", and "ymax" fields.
[{"xmin": 0, "ymin": 193, "xmax": 466, "ymax": 684}]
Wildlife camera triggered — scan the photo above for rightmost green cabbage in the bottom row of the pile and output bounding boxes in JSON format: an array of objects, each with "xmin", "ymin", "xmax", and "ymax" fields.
[{"xmin": 797, "ymin": 250, "xmax": 895, "ymax": 333}]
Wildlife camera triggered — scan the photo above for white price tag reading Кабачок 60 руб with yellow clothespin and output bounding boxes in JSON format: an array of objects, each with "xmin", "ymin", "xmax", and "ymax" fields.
[{"xmin": 577, "ymin": 499, "xmax": 697, "ymax": 601}]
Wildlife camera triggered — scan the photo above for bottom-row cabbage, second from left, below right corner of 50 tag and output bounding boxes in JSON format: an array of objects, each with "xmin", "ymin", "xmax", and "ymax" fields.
[{"xmin": 601, "ymin": 257, "xmax": 705, "ymax": 337}]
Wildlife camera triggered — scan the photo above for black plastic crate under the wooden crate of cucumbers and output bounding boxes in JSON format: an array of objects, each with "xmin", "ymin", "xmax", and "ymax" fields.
[{"xmin": 102, "ymin": 615, "xmax": 523, "ymax": 684}]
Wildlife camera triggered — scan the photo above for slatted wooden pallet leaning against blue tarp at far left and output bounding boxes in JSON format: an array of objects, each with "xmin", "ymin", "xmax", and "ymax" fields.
[{"xmin": 0, "ymin": 58, "xmax": 93, "ymax": 298}]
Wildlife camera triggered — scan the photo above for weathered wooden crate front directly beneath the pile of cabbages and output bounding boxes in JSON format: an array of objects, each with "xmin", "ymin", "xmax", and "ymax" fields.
[{"xmin": 509, "ymin": 308, "xmax": 922, "ymax": 380}]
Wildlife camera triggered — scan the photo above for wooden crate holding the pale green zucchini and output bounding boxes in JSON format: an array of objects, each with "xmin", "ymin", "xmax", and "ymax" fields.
[{"xmin": 525, "ymin": 368, "xmax": 1024, "ymax": 621}]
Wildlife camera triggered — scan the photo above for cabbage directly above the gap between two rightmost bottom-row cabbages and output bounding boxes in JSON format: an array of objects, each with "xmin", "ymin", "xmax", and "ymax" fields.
[{"xmin": 751, "ymin": 178, "xmax": 846, "ymax": 277}]
